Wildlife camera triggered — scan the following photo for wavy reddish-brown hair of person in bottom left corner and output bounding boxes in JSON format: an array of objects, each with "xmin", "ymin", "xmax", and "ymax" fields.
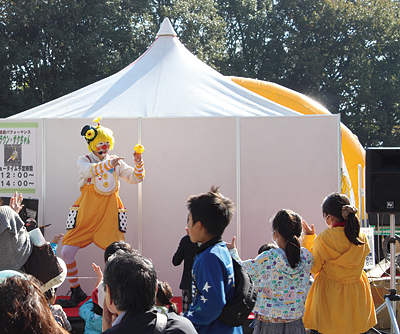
[{"xmin": 0, "ymin": 275, "xmax": 68, "ymax": 334}]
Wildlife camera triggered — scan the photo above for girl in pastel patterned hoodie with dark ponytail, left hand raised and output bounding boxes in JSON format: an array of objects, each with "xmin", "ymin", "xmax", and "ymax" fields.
[{"xmin": 226, "ymin": 209, "xmax": 313, "ymax": 334}]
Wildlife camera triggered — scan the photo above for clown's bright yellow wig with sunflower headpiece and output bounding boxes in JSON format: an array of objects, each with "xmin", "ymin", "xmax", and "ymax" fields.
[{"xmin": 81, "ymin": 117, "xmax": 115, "ymax": 153}]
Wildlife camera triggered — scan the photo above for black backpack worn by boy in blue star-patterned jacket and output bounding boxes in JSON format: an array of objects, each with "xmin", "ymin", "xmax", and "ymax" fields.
[{"xmin": 194, "ymin": 239, "xmax": 257, "ymax": 327}]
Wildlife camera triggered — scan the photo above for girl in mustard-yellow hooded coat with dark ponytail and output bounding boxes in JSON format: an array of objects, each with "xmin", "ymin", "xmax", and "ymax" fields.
[{"xmin": 303, "ymin": 193, "xmax": 376, "ymax": 334}]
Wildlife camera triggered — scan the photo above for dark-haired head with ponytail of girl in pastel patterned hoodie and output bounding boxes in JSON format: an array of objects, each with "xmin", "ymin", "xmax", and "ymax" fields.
[{"xmin": 272, "ymin": 209, "xmax": 302, "ymax": 268}]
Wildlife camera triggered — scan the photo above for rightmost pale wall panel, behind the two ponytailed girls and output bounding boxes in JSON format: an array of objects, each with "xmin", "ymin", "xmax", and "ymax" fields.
[{"xmin": 238, "ymin": 115, "xmax": 340, "ymax": 259}]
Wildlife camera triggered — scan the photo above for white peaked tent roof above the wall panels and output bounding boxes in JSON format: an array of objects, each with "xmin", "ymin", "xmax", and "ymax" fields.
[{"xmin": 9, "ymin": 18, "xmax": 299, "ymax": 118}]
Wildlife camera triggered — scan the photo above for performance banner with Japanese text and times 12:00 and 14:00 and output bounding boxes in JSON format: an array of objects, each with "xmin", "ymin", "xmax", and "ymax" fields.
[{"xmin": 0, "ymin": 123, "xmax": 38, "ymax": 194}]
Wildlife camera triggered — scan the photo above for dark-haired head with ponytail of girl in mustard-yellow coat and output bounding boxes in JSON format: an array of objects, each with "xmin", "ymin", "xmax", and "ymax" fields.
[{"xmin": 322, "ymin": 193, "xmax": 363, "ymax": 245}]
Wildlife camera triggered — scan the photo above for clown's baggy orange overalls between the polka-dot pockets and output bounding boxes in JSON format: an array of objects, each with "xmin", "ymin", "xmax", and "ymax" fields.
[{"xmin": 63, "ymin": 184, "xmax": 125, "ymax": 249}]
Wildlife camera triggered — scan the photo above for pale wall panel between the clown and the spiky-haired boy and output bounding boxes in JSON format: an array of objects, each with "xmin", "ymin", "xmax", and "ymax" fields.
[{"xmin": 142, "ymin": 118, "xmax": 236, "ymax": 295}]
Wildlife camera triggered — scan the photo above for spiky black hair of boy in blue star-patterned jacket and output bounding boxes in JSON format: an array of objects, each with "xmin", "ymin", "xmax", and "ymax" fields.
[{"xmin": 187, "ymin": 187, "xmax": 235, "ymax": 237}]
